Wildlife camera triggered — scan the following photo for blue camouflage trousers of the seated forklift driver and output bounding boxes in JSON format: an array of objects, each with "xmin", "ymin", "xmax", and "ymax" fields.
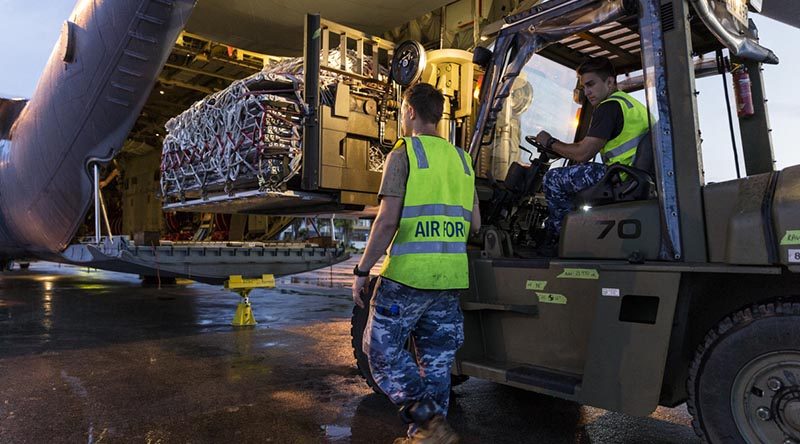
[{"xmin": 542, "ymin": 162, "xmax": 606, "ymax": 234}]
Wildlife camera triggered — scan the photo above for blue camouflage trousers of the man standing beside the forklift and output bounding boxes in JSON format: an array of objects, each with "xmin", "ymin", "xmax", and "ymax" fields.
[{"xmin": 363, "ymin": 277, "xmax": 464, "ymax": 420}]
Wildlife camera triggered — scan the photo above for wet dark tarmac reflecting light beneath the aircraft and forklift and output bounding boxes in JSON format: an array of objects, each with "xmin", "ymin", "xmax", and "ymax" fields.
[{"xmin": 0, "ymin": 259, "xmax": 699, "ymax": 443}]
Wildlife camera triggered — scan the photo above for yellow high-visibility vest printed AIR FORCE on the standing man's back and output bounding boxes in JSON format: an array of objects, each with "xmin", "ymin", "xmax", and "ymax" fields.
[{"xmin": 381, "ymin": 136, "xmax": 475, "ymax": 290}]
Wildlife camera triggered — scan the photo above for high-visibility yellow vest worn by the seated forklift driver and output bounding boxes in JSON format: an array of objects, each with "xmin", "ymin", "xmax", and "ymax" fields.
[{"xmin": 600, "ymin": 91, "xmax": 650, "ymax": 166}]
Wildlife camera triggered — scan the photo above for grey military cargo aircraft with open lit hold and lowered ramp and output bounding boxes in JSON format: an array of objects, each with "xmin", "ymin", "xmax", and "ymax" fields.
[{"xmin": 0, "ymin": 0, "xmax": 800, "ymax": 282}]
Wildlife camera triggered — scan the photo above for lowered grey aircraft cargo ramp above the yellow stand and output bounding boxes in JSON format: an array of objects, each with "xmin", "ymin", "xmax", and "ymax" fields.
[{"xmin": 58, "ymin": 236, "xmax": 350, "ymax": 284}]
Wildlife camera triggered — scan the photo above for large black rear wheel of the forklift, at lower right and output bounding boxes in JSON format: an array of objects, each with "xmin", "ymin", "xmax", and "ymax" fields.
[{"xmin": 687, "ymin": 301, "xmax": 800, "ymax": 444}]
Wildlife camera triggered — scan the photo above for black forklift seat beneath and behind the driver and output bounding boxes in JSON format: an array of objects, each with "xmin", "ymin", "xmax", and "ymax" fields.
[{"xmin": 575, "ymin": 131, "xmax": 656, "ymax": 206}]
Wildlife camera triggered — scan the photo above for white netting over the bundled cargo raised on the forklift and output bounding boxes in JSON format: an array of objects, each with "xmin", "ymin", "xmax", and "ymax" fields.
[{"xmin": 161, "ymin": 50, "xmax": 388, "ymax": 200}]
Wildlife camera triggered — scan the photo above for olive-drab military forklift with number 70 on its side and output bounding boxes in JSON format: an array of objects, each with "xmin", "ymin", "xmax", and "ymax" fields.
[{"xmin": 352, "ymin": 0, "xmax": 800, "ymax": 444}]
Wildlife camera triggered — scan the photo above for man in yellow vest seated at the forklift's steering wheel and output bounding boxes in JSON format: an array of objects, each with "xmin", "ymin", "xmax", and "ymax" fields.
[{"xmin": 536, "ymin": 57, "xmax": 649, "ymax": 256}]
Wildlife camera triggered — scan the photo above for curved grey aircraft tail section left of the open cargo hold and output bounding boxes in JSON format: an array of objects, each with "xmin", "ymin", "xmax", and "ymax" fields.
[{"xmin": 0, "ymin": 0, "xmax": 195, "ymax": 253}]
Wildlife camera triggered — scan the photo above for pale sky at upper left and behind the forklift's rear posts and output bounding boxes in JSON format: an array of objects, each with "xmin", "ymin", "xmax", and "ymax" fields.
[{"xmin": 0, "ymin": 0, "xmax": 800, "ymax": 183}]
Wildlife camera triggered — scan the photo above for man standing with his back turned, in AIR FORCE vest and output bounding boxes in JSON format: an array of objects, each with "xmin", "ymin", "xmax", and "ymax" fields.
[{"xmin": 353, "ymin": 83, "xmax": 480, "ymax": 444}]
